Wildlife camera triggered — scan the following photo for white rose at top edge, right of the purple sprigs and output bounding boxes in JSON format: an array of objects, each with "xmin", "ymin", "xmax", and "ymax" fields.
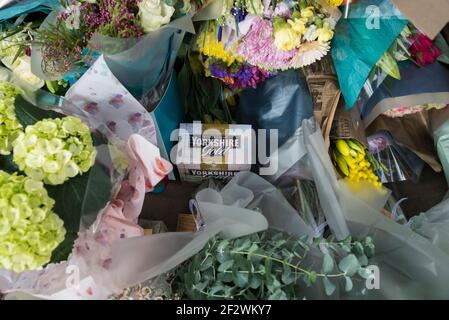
[{"xmin": 139, "ymin": 0, "xmax": 175, "ymax": 32}]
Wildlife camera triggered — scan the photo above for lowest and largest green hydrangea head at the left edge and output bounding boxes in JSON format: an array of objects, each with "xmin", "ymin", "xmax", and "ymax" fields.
[{"xmin": 0, "ymin": 171, "xmax": 66, "ymax": 272}]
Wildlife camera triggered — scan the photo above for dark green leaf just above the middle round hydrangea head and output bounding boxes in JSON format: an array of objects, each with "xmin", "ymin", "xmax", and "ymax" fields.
[{"xmin": 15, "ymin": 96, "xmax": 64, "ymax": 128}]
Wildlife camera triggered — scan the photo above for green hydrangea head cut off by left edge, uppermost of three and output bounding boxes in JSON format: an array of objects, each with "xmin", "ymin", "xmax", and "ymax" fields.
[{"xmin": 0, "ymin": 82, "xmax": 22, "ymax": 155}]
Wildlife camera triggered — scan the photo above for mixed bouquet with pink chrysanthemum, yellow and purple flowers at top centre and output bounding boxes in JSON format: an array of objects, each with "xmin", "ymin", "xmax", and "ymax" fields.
[{"xmin": 197, "ymin": 0, "xmax": 340, "ymax": 89}]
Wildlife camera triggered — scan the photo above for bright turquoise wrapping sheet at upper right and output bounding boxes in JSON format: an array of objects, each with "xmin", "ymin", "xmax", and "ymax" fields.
[{"xmin": 331, "ymin": 0, "xmax": 408, "ymax": 109}]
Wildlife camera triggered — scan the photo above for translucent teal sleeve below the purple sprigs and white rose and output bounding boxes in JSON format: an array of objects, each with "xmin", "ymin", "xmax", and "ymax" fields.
[{"xmin": 91, "ymin": 16, "xmax": 195, "ymax": 100}]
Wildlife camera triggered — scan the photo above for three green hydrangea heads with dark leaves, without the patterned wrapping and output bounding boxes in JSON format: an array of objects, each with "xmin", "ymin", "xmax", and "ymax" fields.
[{"xmin": 0, "ymin": 82, "xmax": 108, "ymax": 272}]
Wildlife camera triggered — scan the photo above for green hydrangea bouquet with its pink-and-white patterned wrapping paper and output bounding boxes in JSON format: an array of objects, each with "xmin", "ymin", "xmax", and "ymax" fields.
[{"xmin": 0, "ymin": 57, "xmax": 171, "ymax": 297}]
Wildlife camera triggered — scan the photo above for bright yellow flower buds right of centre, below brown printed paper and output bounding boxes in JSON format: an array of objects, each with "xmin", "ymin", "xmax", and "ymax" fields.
[{"xmin": 332, "ymin": 139, "xmax": 382, "ymax": 187}]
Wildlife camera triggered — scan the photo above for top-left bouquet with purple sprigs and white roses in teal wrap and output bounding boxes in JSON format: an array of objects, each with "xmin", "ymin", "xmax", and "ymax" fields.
[{"xmin": 0, "ymin": 0, "xmax": 193, "ymax": 101}]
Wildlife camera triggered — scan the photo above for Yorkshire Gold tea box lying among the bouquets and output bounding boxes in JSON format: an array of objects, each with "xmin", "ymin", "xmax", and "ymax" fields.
[{"xmin": 176, "ymin": 122, "xmax": 254, "ymax": 182}]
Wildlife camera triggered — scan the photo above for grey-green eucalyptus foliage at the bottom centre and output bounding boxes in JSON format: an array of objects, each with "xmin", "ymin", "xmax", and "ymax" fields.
[{"xmin": 174, "ymin": 232, "xmax": 374, "ymax": 300}]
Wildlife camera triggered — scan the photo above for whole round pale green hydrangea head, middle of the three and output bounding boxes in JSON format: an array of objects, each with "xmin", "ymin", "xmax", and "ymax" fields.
[{"xmin": 13, "ymin": 116, "xmax": 97, "ymax": 185}]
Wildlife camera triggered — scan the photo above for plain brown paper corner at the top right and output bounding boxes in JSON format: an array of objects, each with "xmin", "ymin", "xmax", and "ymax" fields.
[{"xmin": 392, "ymin": 0, "xmax": 449, "ymax": 39}]
